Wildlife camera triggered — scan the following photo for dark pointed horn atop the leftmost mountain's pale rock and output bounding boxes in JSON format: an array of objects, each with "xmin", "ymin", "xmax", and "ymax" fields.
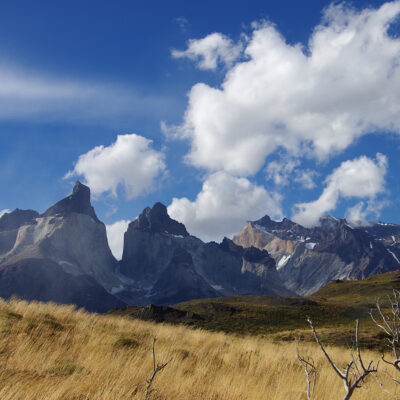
[{"xmin": 42, "ymin": 181, "xmax": 100, "ymax": 222}]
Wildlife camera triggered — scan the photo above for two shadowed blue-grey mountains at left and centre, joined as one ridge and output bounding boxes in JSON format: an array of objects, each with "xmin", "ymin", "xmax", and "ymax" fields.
[{"xmin": 0, "ymin": 182, "xmax": 292, "ymax": 312}]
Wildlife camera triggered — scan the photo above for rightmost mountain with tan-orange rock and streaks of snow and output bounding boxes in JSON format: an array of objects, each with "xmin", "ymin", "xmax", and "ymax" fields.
[{"xmin": 233, "ymin": 216, "xmax": 400, "ymax": 295}]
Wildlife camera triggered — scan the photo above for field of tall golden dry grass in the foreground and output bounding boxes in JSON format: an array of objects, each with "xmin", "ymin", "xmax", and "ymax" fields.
[{"xmin": 0, "ymin": 300, "xmax": 400, "ymax": 400}]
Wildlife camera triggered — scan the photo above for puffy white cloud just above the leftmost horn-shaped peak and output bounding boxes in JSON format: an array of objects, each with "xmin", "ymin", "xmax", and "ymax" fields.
[{"xmin": 66, "ymin": 134, "xmax": 166, "ymax": 199}]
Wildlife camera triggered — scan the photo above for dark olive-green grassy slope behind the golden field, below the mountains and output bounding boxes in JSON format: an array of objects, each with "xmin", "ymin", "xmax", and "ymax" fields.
[{"xmin": 166, "ymin": 271, "xmax": 400, "ymax": 350}]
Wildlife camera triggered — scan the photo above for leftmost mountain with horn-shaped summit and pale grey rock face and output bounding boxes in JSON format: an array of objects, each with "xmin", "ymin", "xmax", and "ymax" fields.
[{"xmin": 0, "ymin": 182, "xmax": 123, "ymax": 311}]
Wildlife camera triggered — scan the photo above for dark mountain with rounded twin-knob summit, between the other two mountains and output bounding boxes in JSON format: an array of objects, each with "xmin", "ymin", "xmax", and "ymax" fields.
[{"xmin": 118, "ymin": 203, "xmax": 291, "ymax": 304}]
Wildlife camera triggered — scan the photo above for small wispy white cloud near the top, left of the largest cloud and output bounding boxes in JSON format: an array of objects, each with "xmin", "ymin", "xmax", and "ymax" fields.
[{"xmin": 172, "ymin": 33, "xmax": 242, "ymax": 70}]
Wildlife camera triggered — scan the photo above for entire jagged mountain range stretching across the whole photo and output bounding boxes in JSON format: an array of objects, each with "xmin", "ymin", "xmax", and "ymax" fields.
[{"xmin": 0, "ymin": 182, "xmax": 400, "ymax": 312}]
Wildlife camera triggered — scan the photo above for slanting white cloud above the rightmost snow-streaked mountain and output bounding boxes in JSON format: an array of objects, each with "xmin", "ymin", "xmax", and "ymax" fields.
[{"xmin": 292, "ymin": 153, "xmax": 387, "ymax": 226}]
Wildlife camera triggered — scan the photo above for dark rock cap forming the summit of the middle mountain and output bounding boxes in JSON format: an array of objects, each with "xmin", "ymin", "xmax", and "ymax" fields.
[{"xmin": 128, "ymin": 203, "xmax": 189, "ymax": 237}]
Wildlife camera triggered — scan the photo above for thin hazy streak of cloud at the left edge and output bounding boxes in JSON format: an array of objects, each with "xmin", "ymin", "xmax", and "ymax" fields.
[{"xmin": 0, "ymin": 60, "xmax": 171, "ymax": 121}]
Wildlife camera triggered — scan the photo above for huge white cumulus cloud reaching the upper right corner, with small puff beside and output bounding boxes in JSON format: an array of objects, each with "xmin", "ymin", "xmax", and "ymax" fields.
[{"xmin": 165, "ymin": 1, "xmax": 400, "ymax": 176}]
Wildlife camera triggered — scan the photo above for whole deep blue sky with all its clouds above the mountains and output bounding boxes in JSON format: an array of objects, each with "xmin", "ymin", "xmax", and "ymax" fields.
[{"xmin": 0, "ymin": 0, "xmax": 400, "ymax": 257}]
